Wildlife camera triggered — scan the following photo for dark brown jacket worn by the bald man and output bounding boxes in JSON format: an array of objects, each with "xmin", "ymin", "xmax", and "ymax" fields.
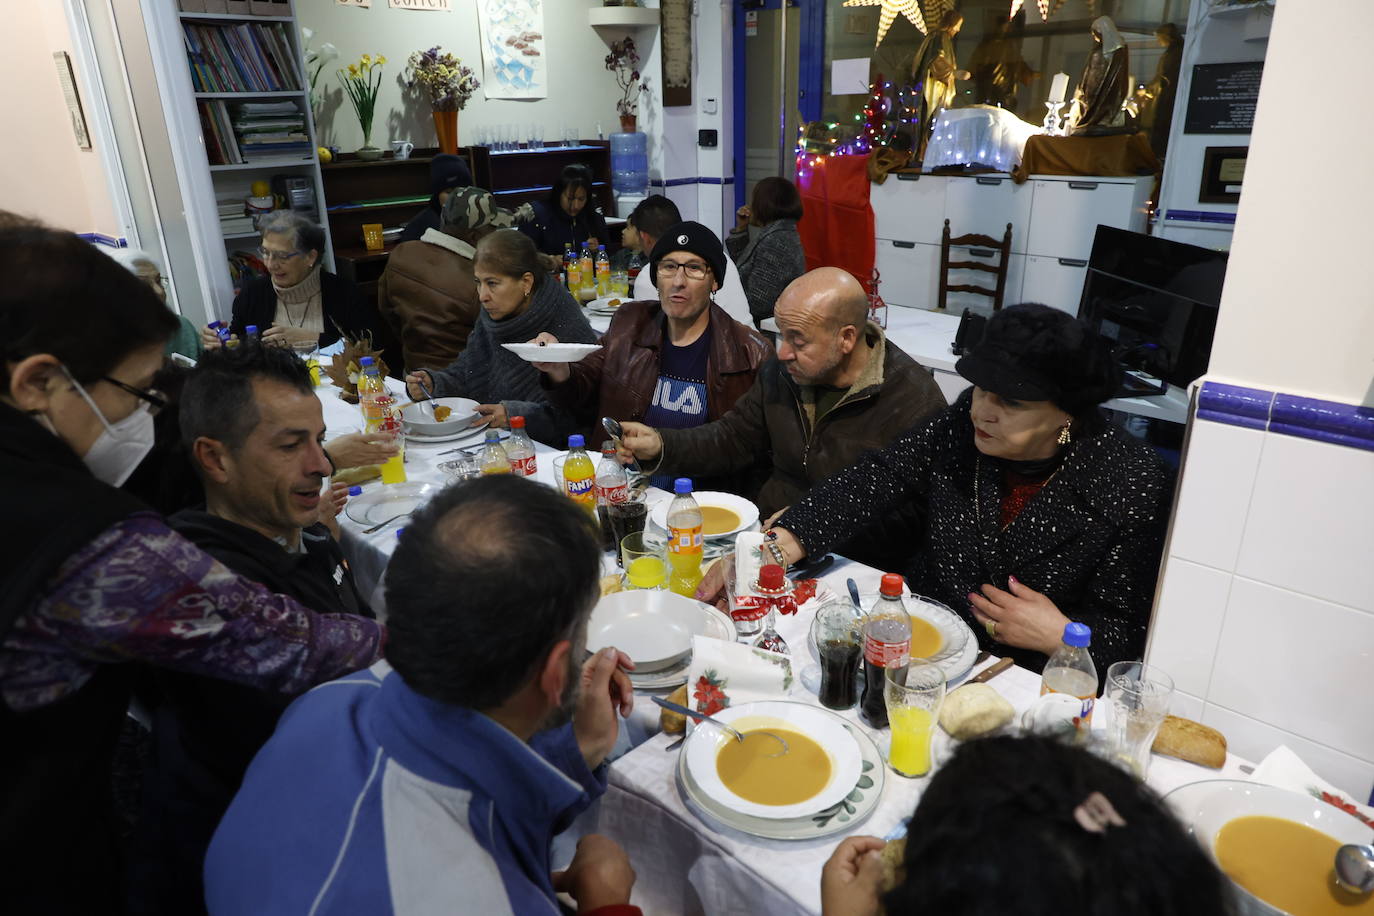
[{"xmin": 644, "ymin": 329, "xmax": 945, "ymax": 569}]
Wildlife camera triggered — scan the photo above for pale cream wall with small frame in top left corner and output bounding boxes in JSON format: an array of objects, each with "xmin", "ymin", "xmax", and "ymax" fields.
[{"xmin": 0, "ymin": 0, "xmax": 120, "ymax": 238}]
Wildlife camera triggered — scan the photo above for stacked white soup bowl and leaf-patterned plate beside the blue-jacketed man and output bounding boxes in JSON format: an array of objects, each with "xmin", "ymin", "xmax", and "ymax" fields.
[{"xmin": 677, "ymin": 700, "xmax": 886, "ymax": 840}]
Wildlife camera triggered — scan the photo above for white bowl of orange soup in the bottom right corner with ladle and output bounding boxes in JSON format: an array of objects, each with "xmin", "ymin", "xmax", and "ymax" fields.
[{"xmin": 1164, "ymin": 779, "xmax": 1374, "ymax": 916}]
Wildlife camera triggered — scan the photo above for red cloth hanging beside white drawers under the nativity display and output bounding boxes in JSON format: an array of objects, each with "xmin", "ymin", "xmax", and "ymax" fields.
[{"xmin": 797, "ymin": 155, "xmax": 877, "ymax": 293}]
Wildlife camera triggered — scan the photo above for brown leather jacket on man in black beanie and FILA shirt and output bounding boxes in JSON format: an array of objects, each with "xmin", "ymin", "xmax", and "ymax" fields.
[{"xmin": 544, "ymin": 299, "xmax": 772, "ymax": 444}]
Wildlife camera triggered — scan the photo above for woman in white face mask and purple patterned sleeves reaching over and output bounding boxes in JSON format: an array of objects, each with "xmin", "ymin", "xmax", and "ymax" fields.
[{"xmin": 0, "ymin": 211, "xmax": 383, "ymax": 913}]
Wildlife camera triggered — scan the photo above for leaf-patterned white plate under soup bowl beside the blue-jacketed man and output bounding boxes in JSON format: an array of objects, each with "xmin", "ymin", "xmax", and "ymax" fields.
[{"xmin": 677, "ymin": 710, "xmax": 888, "ymax": 840}]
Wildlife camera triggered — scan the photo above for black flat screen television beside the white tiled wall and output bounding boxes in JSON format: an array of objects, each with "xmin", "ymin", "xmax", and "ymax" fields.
[{"xmin": 1079, "ymin": 225, "xmax": 1227, "ymax": 396}]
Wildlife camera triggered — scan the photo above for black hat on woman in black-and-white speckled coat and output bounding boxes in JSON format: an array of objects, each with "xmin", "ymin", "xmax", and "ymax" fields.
[{"xmin": 954, "ymin": 304, "xmax": 1121, "ymax": 416}]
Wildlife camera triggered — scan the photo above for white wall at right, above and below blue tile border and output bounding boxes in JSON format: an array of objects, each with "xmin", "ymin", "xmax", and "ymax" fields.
[{"xmin": 1149, "ymin": 0, "xmax": 1374, "ymax": 801}]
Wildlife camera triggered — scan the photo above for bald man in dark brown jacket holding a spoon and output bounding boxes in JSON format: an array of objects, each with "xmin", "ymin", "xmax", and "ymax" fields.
[{"xmin": 624, "ymin": 268, "xmax": 945, "ymax": 569}]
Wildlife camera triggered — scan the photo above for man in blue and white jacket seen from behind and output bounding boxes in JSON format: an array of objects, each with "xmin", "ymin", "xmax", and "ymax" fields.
[{"xmin": 205, "ymin": 475, "xmax": 639, "ymax": 916}]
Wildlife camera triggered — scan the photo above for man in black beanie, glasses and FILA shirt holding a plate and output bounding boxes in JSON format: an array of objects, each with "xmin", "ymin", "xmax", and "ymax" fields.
[{"xmin": 534, "ymin": 222, "xmax": 772, "ymax": 489}]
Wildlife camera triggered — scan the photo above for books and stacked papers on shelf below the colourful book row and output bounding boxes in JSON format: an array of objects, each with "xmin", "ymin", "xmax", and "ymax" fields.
[{"xmin": 196, "ymin": 99, "xmax": 313, "ymax": 165}]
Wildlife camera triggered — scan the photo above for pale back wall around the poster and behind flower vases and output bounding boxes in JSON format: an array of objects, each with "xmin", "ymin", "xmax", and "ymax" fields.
[{"xmin": 295, "ymin": 0, "xmax": 623, "ymax": 152}]
